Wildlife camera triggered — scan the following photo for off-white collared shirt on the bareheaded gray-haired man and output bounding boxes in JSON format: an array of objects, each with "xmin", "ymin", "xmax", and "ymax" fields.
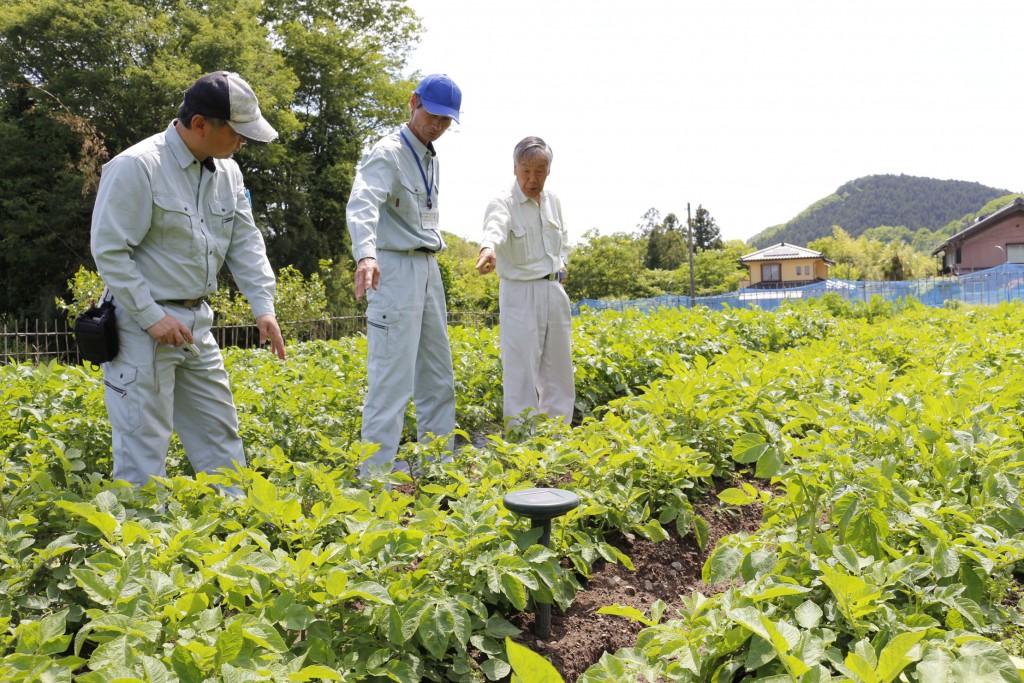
[{"xmin": 480, "ymin": 180, "xmax": 568, "ymax": 281}]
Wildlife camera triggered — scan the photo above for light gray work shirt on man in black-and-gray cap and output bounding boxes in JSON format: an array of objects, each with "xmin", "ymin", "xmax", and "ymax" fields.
[{"xmin": 92, "ymin": 121, "xmax": 274, "ymax": 330}]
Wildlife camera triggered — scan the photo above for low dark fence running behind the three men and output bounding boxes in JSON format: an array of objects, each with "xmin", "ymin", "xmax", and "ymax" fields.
[{"xmin": 0, "ymin": 311, "xmax": 498, "ymax": 365}]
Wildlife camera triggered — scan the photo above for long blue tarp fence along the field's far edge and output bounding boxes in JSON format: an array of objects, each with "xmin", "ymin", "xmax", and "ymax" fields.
[{"xmin": 572, "ymin": 263, "xmax": 1024, "ymax": 315}]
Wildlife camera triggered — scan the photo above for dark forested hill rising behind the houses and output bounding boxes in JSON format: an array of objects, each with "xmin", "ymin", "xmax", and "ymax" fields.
[{"xmin": 748, "ymin": 175, "xmax": 1010, "ymax": 249}]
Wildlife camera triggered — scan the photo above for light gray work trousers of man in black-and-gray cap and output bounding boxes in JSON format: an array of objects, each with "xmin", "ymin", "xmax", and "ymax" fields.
[{"xmin": 103, "ymin": 303, "xmax": 246, "ymax": 485}]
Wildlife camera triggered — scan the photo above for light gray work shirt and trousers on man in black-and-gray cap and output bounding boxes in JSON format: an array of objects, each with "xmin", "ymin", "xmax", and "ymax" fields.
[{"xmin": 91, "ymin": 122, "xmax": 274, "ymax": 485}]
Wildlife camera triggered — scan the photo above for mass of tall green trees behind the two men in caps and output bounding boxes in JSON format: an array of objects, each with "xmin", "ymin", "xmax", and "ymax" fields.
[{"xmin": 0, "ymin": 0, "xmax": 421, "ymax": 315}]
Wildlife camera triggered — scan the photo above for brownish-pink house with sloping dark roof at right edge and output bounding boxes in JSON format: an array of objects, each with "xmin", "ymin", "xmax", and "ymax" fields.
[{"xmin": 932, "ymin": 197, "xmax": 1024, "ymax": 275}]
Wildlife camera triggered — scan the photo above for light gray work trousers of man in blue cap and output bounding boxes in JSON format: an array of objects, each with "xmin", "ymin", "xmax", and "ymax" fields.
[{"xmin": 359, "ymin": 250, "xmax": 455, "ymax": 476}]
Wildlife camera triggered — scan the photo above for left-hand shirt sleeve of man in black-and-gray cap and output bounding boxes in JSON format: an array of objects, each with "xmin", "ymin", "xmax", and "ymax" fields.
[{"xmin": 90, "ymin": 157, "xmax": 165, "ymax": 330}]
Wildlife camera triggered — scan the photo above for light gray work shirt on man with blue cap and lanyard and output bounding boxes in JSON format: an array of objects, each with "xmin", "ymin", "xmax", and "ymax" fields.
[{"xmin": 345, "ymin": 124, "xmax": 444, "ymax": 263}]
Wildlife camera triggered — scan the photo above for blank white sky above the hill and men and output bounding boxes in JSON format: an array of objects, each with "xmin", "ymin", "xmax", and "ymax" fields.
[{"xmin": 409, "ymin": 0, "xmax": 1024, "ymax": 243}]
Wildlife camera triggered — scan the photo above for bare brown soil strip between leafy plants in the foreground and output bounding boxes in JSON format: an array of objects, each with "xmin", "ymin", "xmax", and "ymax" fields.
[{"xmin": 512, "ymin": 486, "xmax": 762, "ymax": 683}]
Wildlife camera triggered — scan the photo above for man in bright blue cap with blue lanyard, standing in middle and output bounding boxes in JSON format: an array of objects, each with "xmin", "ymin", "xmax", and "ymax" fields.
[{"xmin": 346, "ymin": 74, "xmax": 462, "ymax": 477}]
